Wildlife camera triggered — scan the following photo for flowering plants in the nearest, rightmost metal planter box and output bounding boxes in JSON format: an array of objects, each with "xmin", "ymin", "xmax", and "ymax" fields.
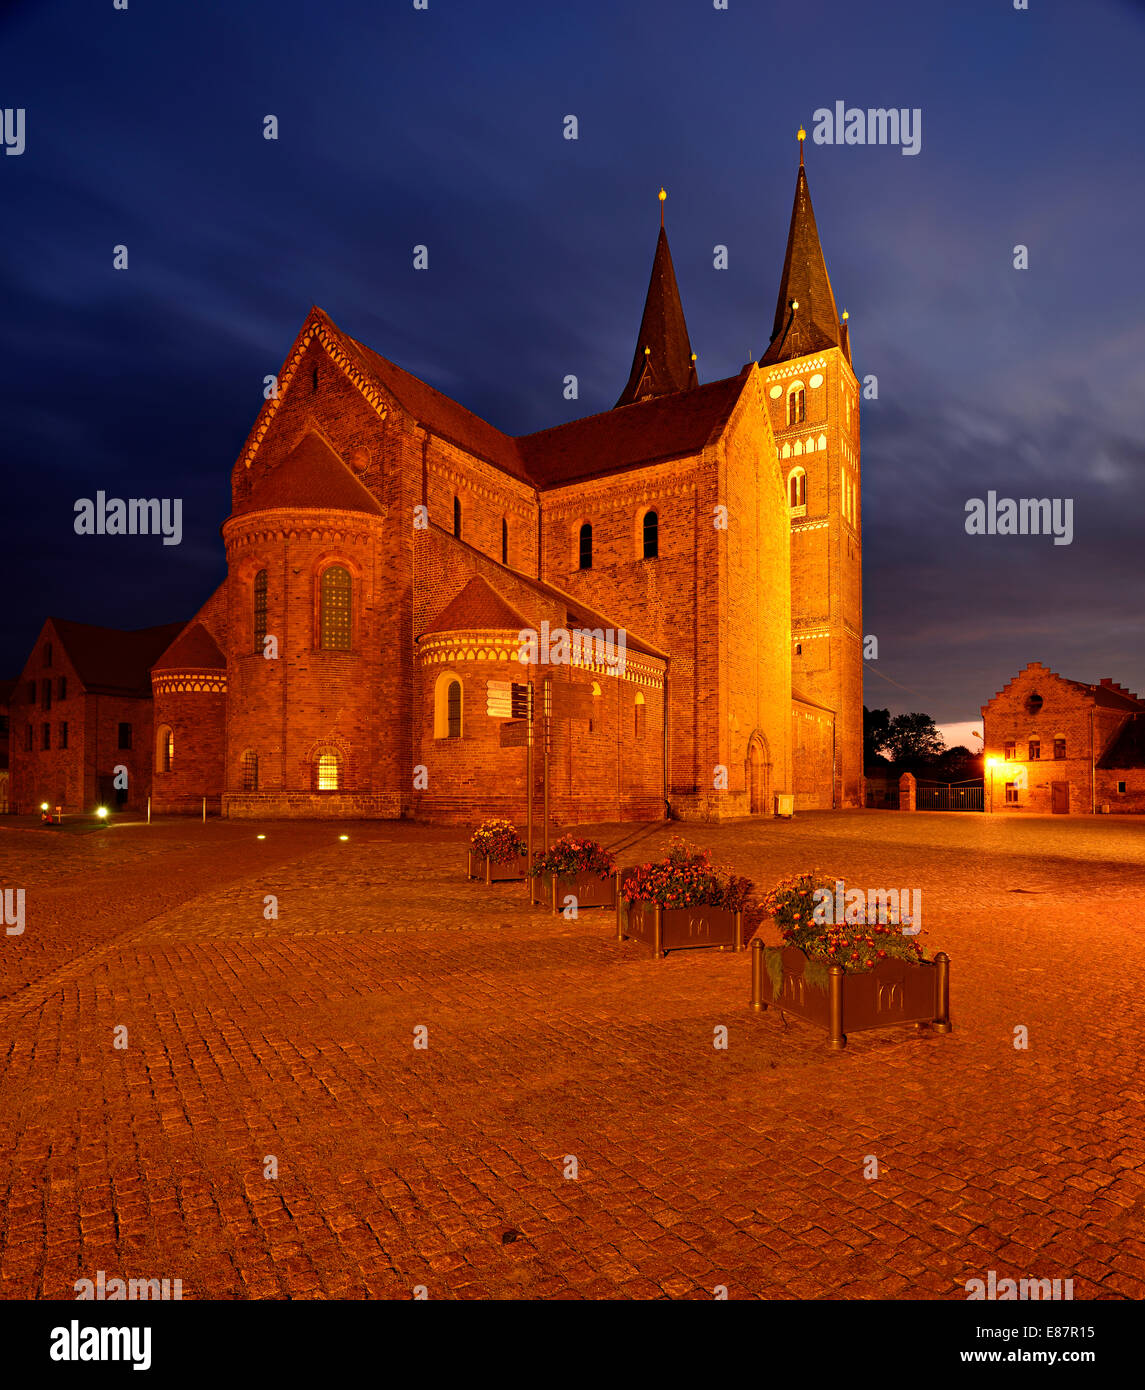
[{"xmin": 763, "ymin": 870, "xmax": 927, "ymax": 974}]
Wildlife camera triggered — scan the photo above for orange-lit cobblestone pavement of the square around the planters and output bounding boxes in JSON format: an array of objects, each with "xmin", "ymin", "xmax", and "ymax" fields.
[{"xmin": 0, "ymin": 812, "xmax": 1145, "ymax": 1298}]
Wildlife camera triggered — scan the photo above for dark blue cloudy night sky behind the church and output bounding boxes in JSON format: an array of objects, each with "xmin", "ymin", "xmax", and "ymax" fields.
[{"xmin": 0, "ymin": 0, "xmax": 1145, "ymax": 723}]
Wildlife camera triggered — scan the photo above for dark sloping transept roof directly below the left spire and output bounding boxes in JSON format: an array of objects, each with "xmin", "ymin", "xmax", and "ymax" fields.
[{"xmin": 517, "ymin": 368, "xmax": 746, "ymax": 488}]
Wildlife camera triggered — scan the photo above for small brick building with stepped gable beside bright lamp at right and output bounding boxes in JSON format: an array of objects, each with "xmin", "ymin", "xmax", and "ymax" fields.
[{"xmin": 982, "ymin": 662, "xmax": 1145, "ymax": 816}]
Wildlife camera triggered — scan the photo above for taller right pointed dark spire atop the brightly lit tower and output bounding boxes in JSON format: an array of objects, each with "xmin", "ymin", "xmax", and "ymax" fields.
[{"xmin": 760, "ymin": 126, "xmax": 841, "ymax": 364}]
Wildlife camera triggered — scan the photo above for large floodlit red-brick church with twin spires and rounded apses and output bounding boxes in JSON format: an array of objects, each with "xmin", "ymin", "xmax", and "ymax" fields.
[{"xmin": 13, "ymin": 132, "xmax": 863, "ymax": 823}]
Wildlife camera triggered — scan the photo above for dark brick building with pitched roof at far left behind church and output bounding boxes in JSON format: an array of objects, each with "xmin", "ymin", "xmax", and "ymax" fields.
[{"xmin": 8, "ymin": 619, "xmax": 182, "ymax": 815}]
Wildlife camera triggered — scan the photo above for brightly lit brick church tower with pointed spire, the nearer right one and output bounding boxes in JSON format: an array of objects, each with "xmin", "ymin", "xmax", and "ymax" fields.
[{"xmin": 760, "ymin": 129, "xmax": 863, "ymax": 809}]
